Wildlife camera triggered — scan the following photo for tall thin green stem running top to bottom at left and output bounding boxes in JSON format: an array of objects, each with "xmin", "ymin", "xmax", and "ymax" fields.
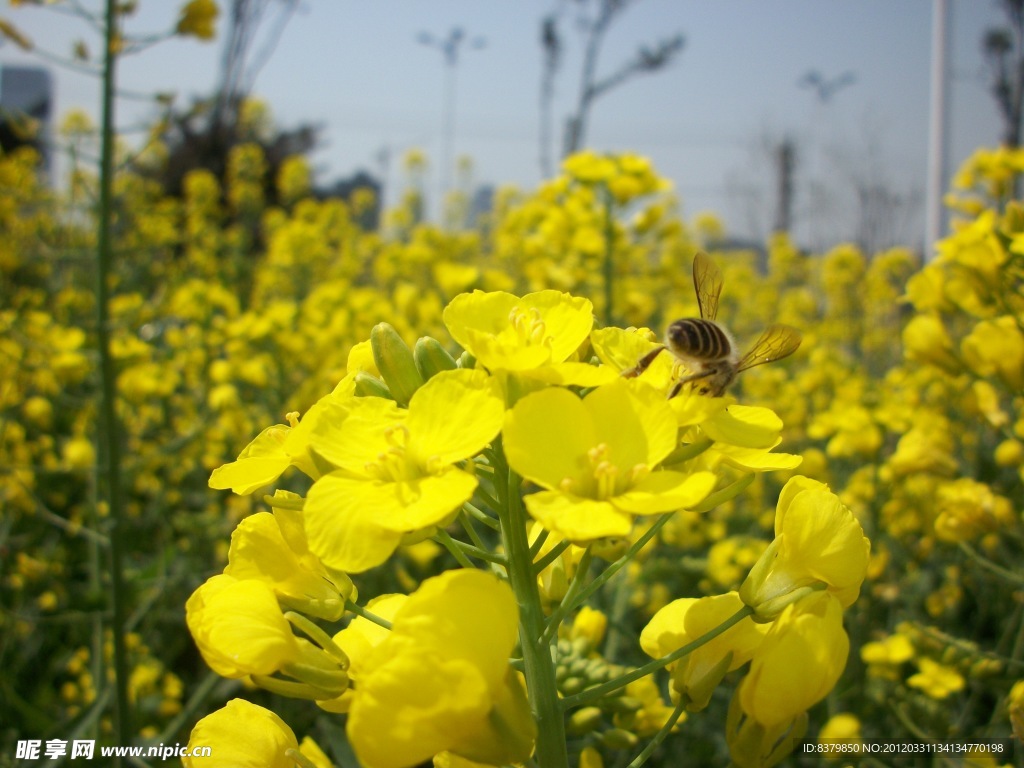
[{"xmin": 96, "ymin": 0, "xmax": 133, "ymax": 753}]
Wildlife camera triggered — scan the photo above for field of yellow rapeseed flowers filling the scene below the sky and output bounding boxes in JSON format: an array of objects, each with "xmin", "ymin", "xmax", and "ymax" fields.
[{"xmin": 0, "ymin": 96, "xmax": 1024, "ymax": 768}]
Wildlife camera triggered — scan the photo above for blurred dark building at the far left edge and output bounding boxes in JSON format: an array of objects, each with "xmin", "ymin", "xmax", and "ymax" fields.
[{"xmin": 0, "ymin": 65, "xmax": 53, "ymax": 179}]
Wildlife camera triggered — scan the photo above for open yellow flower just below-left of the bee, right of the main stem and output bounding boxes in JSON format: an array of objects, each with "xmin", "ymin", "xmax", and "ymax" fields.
[{"xmin": 504, "ymin": 380, "xmax": 715, "ymax": 542}]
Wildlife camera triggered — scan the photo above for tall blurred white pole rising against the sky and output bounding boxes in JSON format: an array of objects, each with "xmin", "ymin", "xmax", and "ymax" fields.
[{"xmin": 925, "ymin": 0, "xmax": 949, "ymax": 261}]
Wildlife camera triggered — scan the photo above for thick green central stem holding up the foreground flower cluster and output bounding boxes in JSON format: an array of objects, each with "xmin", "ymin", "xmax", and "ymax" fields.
[{"xmin": 494, "ymin": 438, "xmax": 568, "ymax": 768}]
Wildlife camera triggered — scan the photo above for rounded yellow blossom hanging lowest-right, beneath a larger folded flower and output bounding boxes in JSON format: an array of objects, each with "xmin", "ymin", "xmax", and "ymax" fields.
[{"xmin": 737, "ymin": 592, "xmax": 850, "ymax": 728}]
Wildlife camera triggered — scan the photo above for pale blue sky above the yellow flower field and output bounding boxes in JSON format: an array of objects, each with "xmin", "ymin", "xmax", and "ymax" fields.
[{"xmin": 0, "ymin": 0, "xmax": 1001, "ymax": 245}]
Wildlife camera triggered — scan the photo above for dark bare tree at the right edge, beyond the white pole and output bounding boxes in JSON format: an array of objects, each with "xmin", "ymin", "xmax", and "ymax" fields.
[{"xmin": 981, "ymin": 0, "xmax": 1024, "ymax": 146}]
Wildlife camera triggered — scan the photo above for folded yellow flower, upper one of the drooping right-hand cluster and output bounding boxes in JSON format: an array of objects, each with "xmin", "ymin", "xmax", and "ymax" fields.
[{"xmin": 739, "ymin": 475, "xmax": 870, "ymax": 620}]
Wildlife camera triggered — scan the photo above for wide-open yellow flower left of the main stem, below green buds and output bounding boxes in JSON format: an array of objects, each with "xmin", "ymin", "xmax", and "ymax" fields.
[{"xmin": 304, "ymin": 370, "xmax": 504, "ymax": 573}]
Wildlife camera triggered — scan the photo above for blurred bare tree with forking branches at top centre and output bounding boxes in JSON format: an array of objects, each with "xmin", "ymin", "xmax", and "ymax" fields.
[{"xmin": 562, "ymin": 0, "xmax": 684, "ymax": 155}]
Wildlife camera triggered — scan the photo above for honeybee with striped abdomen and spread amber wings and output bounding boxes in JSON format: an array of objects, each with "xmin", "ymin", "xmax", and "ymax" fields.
[{"xmin": 623, "ymin": 253, "xmax": 801, "ymax": 398}]
